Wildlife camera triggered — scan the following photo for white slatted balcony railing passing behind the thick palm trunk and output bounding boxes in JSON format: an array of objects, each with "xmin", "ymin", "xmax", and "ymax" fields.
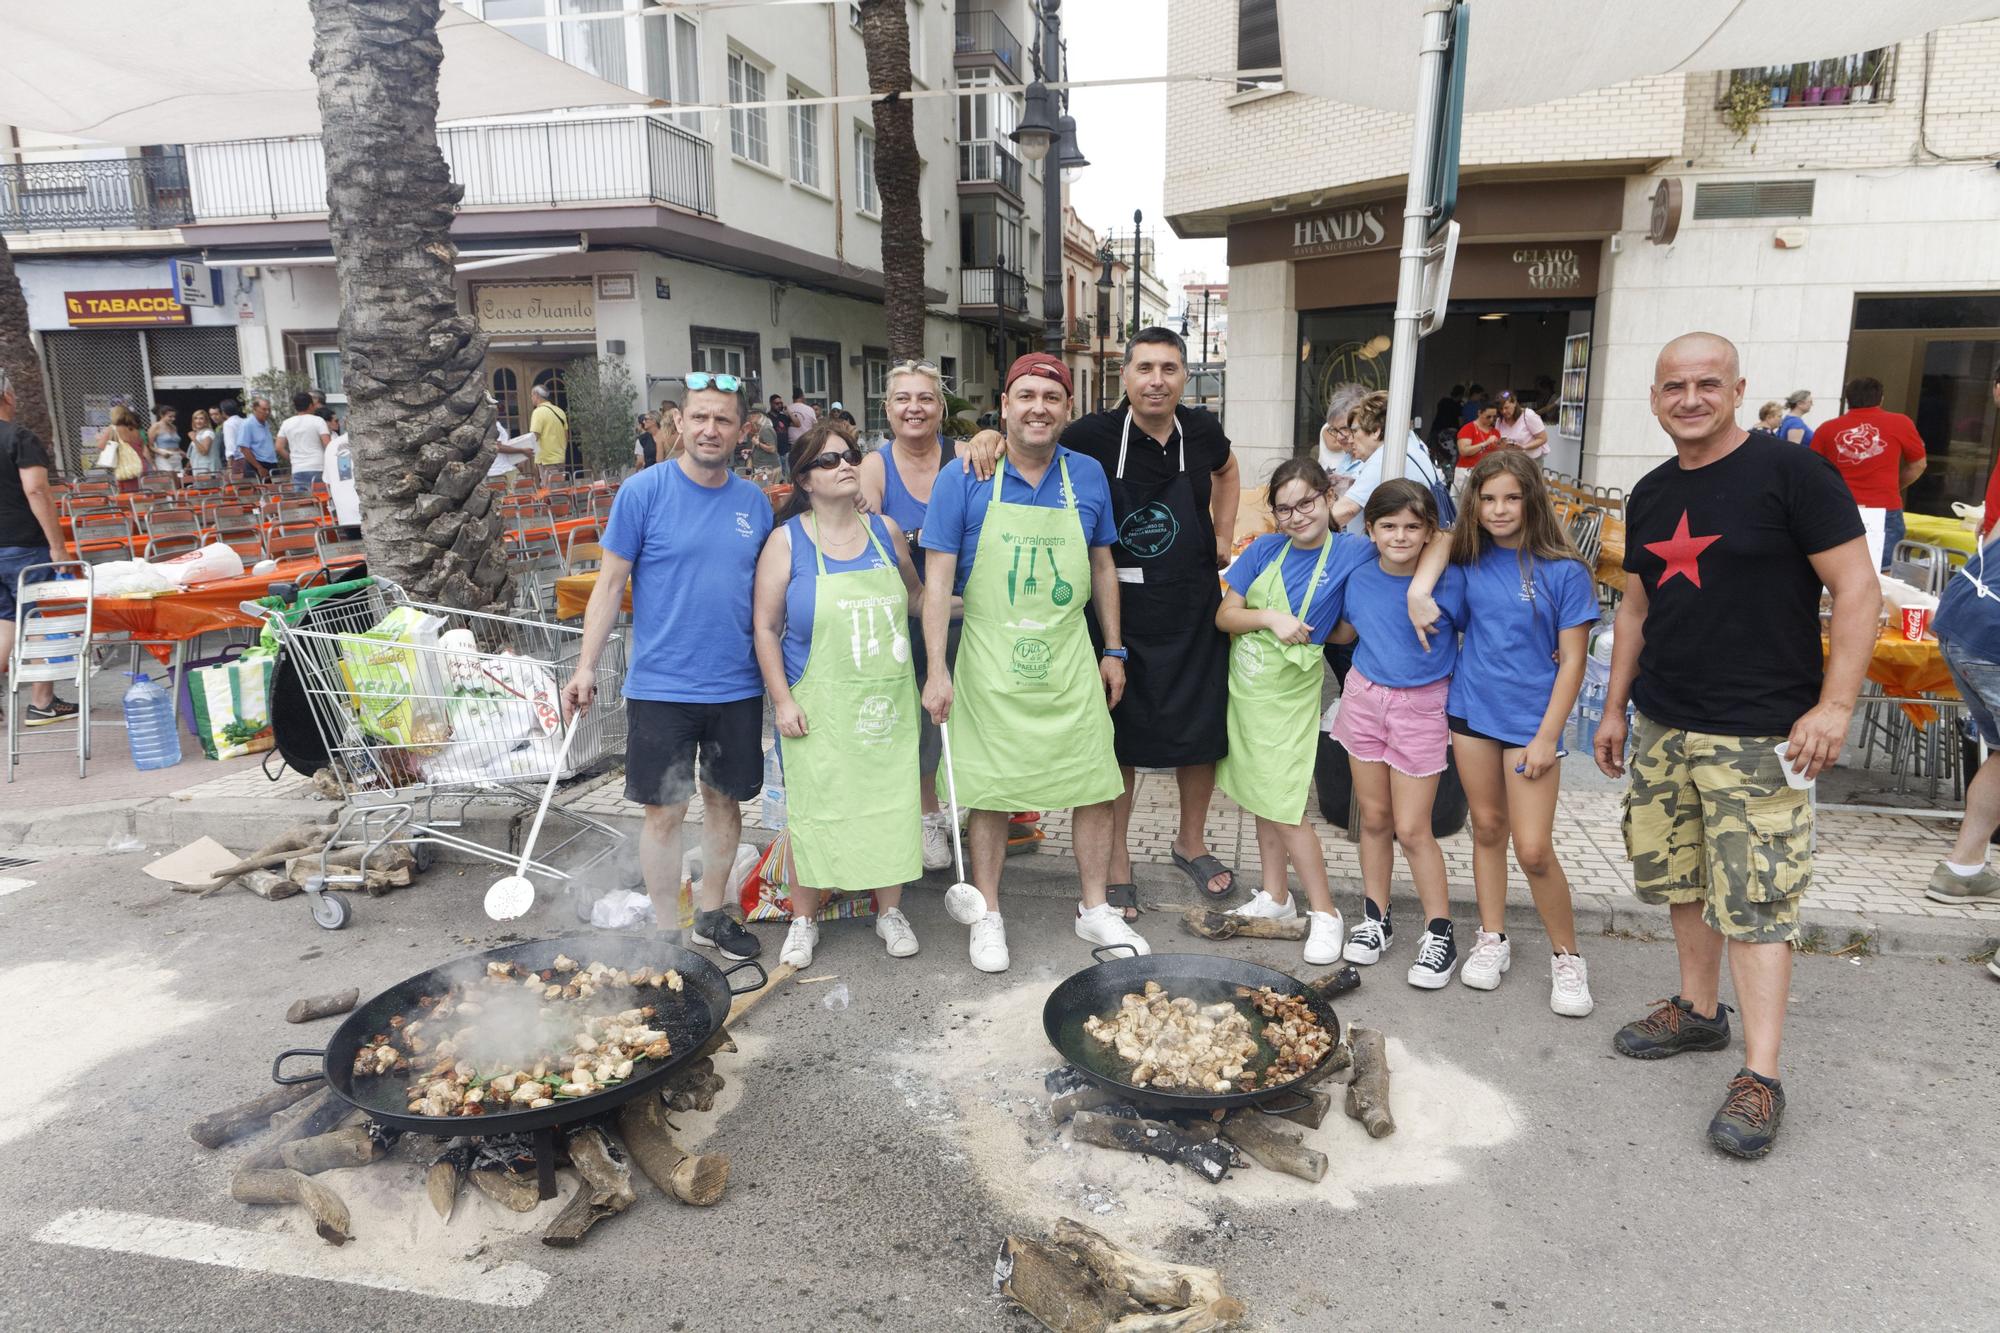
[{"xmin": 188, "ymin": 116, "xmax": 716, "ymax": 218}]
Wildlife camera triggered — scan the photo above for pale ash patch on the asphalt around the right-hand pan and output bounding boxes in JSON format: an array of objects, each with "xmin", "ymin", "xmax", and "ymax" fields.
[{"xmin": 886, "ymin": 975, "xmax": 1516, "ymax": 1245}]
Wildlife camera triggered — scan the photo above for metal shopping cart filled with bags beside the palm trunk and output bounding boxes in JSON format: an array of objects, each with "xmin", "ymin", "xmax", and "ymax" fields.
[{"xmin": 242, "ymin": 578, "xmax": 626, "ymax": 931}]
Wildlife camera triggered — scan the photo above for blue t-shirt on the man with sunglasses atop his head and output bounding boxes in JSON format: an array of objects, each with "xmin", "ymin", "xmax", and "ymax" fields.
[{"xmin": 602, "ymin": 460, "xmax": 770, "ymax": 703}]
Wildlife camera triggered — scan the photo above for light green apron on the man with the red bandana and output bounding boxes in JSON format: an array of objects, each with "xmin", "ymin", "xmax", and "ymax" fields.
[{"xmin": 938, "ymin": 458, "xmax": 1124, "ymax": 811}]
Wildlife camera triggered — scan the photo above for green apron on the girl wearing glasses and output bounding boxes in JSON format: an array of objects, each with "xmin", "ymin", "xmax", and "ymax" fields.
[{"xmin": 1216, "ymin": 532, "xmax": 1334, "ymax": 825}]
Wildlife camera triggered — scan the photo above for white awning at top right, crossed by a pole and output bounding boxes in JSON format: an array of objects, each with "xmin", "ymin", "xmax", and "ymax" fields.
[{"xmin": 1278, "ymin": 0, "xmax": 2000, "ymax": 112}]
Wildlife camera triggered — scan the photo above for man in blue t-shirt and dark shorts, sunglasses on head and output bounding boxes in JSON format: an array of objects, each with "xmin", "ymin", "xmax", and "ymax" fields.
[{"xmin": 562, "ymin": 372, "xmax": 770, "ymax": 959}]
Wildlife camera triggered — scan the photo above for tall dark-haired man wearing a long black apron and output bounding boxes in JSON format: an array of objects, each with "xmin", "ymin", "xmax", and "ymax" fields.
[{"xmin": 1062, "ymin": 328, "xmax": 1240, "ymax": 909}]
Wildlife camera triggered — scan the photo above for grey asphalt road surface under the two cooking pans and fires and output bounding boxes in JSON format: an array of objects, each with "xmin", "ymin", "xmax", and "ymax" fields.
[{"xmin": 0, "ymin": 844, "xmax": 2000, "ymax": 1333}]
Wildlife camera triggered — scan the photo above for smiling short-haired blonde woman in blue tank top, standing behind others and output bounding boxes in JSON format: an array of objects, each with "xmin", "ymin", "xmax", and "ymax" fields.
[{"xmin": 862, "ymin": 360, "xmax": 958, "ymax": 871}]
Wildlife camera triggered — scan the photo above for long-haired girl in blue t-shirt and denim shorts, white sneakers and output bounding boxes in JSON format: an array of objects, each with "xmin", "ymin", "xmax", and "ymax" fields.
[{"xmin": 1414, "ymin": 452, "xmax": 1598, "ymax": 1019}]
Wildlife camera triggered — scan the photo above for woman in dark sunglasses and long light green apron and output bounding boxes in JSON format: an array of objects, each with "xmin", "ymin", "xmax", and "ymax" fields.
[{"xmin": 754, "ymin": 416, "xmax": 924, "ymax": 967}]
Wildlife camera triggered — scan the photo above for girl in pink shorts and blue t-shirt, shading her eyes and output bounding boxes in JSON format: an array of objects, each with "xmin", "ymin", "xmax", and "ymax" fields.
[{"xmin": 1332, "ymin": 478, "xmax": 1466, "ymax": 991}]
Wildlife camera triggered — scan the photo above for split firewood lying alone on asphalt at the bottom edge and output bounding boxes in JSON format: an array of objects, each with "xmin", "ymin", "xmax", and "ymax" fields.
[{"xmin": 994, "ymin": 1217, "xmax": 1246, "ymax": 1333}]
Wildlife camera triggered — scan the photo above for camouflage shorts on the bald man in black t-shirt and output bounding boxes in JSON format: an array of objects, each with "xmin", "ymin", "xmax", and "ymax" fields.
[{"xmin": 1624, "ymin": 715, "xmax": 1812, "ymax": 945}]
